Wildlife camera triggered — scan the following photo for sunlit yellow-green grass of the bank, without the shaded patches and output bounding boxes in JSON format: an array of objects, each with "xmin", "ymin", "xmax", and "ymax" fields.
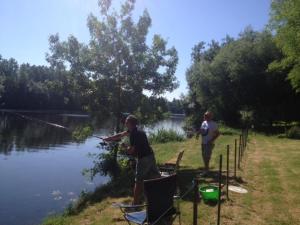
[{"xmin": 44, "ymin": 131, "xmax": 300, "ymax": 225}]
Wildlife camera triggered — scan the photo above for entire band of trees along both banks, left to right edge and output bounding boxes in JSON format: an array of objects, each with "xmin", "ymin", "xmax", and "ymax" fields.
[{"xmin": 0, "ymin": 0, "xmax": 300, "ymax": 128}]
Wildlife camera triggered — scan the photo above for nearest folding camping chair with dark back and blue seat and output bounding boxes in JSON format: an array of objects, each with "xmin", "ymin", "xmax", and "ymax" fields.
[{"xmin": 115, "ymin": 174, "xmax": 181, "ymax": 225}]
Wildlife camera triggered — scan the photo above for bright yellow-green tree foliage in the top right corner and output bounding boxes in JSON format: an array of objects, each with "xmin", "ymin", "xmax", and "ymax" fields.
[{"xmin": 270, "ymin": 0, "xmax": 300, "ymax": 92}]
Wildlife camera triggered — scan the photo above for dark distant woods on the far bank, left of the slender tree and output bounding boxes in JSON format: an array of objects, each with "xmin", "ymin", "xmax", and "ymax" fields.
[{"xmin": 0, "ymin": 55, "xmax": 90, "ymax": 111}]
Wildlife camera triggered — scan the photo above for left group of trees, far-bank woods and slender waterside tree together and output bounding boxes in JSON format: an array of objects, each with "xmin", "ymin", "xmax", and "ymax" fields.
[{"xmin": 0, "ymin": 0, "xmax": 178, "ymax": 124}]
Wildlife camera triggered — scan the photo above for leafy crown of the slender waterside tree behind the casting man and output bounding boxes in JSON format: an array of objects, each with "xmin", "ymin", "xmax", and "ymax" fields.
[{"xmin": 47, "ymin": 0, "xmax": 178, "ymax": 130}]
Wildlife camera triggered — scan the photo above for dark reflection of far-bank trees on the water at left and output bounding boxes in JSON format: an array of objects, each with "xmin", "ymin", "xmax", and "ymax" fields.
[{"xmin": 0, "ymin": 113, "xmax": 88, "ymax": 154}]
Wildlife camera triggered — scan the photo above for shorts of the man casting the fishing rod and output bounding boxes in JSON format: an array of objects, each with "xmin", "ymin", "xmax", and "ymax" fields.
[{"xmin": 135, "ymin": 154, "xmax": 160, "ymax": 182}]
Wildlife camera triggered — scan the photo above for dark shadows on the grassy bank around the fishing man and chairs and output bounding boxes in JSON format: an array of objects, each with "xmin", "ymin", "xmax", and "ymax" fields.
[{"xmin": 65, "ymin": 167, "xmax": 245, "ymax": 215}]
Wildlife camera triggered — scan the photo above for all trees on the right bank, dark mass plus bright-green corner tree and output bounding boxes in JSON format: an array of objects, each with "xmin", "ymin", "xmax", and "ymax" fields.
[{"xmin": 184, "ymin": 0, "xmax": 300, "ymax": 127}]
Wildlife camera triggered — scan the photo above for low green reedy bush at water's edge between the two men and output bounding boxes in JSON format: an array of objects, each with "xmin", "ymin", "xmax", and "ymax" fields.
[{"xmin": 149, "ymin": 129, "xmax": 185, "ymax": 143}]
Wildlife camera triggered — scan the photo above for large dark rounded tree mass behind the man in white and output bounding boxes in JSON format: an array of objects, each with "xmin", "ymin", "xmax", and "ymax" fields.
[{"xmin": 185, "ymin": 27, "xmax": 300, "ymax": 126}]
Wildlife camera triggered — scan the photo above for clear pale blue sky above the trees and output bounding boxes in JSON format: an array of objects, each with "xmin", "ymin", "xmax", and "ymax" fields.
[{"xmin": 0, "ymin": 0, "xmax": 271, "ymax": 100}]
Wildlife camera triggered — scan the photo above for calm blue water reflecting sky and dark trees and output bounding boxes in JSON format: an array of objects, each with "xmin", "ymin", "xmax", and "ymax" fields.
[{"xmin": 0, "ymin": 113, "xmax": 182, "ymax": 225}]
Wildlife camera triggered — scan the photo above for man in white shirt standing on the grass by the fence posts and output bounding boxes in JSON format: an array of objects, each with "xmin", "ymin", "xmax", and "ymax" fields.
[{"xmin": 199, "ymin": 111, "xmax": 220, "ymax": 172}]
